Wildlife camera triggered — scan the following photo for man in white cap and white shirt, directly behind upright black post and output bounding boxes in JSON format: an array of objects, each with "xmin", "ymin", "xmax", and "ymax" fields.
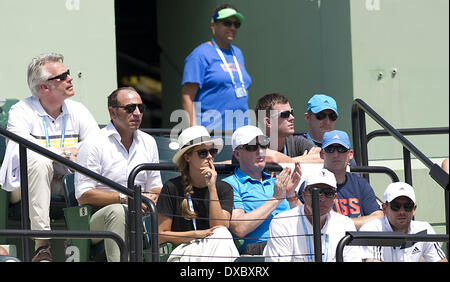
[{"xmin": 264, "ymin": 169, "xmax": 361, "ymax": 262}]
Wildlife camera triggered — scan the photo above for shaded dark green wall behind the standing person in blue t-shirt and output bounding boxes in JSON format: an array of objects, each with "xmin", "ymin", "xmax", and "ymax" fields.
[{"xmin": 157, "ymin": 0, "xmax": 352, "ymax": 133}]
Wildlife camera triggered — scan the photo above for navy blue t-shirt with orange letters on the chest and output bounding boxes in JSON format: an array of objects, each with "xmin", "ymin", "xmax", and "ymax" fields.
[{"xmin": 298, "ymin": 172, "xmax": 380, "ymax": 217}]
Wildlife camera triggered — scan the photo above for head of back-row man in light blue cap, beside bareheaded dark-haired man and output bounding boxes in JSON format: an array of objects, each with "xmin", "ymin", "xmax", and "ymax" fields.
[{"xmin": 304, "ymin": 94, "xmax": 339, "ymax": 147}]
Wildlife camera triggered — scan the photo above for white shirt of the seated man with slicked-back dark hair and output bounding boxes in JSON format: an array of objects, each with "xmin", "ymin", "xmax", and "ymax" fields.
[{"xmin": 75, "ymin": 122, "xmax": 162, "ymax": 199}]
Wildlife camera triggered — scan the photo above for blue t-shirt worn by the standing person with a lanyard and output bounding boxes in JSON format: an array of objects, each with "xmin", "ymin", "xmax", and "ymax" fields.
[{"xmin": 181, "ymin": 41, "xmax": 252, "ymax": 130}]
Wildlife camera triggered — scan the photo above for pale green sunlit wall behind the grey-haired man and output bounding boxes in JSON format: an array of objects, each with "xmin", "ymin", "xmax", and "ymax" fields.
[{"xmin": 0, "ymin": 0, "xmax": 117, "ymax": 124}]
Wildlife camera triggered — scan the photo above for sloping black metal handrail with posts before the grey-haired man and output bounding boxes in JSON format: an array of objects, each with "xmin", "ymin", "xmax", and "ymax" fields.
[{"xmin": 0, "ymin": 127, "xmax": 142, "ymax": 261}]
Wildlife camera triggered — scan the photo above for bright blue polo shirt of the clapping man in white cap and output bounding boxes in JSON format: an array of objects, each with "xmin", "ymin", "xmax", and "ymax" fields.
[{"xmin": 222, "ymin": 168, "xmax": 290, "ymax": 250}]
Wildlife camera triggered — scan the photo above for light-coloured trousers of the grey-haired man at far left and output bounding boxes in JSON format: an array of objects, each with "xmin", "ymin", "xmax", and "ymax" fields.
[{"xmin": 10, "ymin": 154, "xmax": 64, "ymax": 230}]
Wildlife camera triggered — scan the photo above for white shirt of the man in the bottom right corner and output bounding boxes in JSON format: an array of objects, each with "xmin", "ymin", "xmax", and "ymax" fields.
[{"xmin": 359, "ymin": 216, "xmax": 445, "ymax": 262}]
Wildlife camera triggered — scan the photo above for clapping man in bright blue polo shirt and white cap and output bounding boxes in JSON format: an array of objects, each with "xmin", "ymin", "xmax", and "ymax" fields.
[{"xmin": 223, "ymin": 125, "xmax": 301, "ymax": 255}]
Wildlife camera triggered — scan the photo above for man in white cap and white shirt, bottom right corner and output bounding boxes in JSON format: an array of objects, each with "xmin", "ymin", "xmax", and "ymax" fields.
[{"xmin": 359, "ymin": 182, "xmax": 447, "ymax": 262}]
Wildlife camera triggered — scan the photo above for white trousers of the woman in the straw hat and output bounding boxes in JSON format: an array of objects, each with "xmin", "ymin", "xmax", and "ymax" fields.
[{"xmin": 167, "ymin": 227, "xmax": 239, "ymax": 262}]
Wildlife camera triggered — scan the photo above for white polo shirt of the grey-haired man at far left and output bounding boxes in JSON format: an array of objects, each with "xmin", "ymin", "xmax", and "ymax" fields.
[{"xmin": 0, "ymin": 96, "xmax": 100, "ymax": 191}]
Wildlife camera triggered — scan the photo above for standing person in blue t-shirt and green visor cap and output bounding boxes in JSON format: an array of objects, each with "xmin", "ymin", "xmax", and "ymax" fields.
[{"xmin": 181, "ymin": 4, "xmax": 252, "ymax": 130}]
